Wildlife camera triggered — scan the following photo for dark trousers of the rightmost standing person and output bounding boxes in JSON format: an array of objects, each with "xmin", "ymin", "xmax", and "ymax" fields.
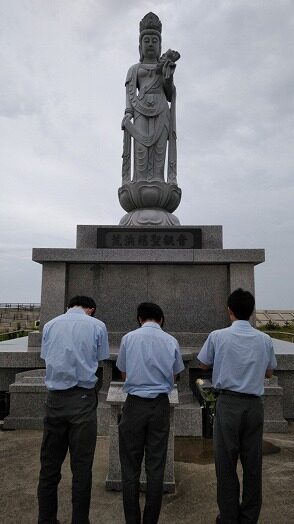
[{"xmin": 214, "ymin": 394, "xmax": 264, "ymax": 524}]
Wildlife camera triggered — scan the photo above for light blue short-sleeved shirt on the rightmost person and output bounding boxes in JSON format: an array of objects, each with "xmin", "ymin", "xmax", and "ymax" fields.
[{"xmin": 198, "ymin": 320, "xmax": 277, "ymax": 396}]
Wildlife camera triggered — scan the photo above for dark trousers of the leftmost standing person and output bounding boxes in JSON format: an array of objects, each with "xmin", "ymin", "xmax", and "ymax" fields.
[{"xmin": 38, "ymin": 388, "xmax": 97, "ymax": 524}]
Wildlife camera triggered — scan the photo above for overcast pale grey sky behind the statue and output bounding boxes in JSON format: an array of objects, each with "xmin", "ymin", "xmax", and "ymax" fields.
[{"xmin": 0, "ymin": 0, "xmax": 294, "ymax": 309}]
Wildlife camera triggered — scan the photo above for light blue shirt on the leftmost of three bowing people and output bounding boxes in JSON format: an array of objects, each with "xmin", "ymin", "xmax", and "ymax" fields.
[{"xmin": 41, "ymin": 307, "xmax": 109, "ymax": 390}]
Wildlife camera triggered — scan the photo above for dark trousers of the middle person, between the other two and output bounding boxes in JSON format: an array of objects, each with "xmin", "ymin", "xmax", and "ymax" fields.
[{"xmin": 119, "ymin": 395, "xmax": 170, "ymax": 524}]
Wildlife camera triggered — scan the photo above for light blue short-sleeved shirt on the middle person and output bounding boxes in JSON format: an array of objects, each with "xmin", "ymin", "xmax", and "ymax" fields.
[{"xmin": 116, "ymin": 321, "xmax": 184, "ymax": 398}]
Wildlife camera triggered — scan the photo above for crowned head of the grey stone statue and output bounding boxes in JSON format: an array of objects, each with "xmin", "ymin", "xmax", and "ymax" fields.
[{"xmin": 139, "ymin": 13, "xmax": 162, "ymax": 62}]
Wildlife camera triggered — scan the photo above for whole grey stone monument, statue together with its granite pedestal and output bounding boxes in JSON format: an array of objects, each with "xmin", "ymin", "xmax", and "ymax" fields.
[{"xmin": 1, "ymin": 13, "xmax": 288, "ymax": 436}]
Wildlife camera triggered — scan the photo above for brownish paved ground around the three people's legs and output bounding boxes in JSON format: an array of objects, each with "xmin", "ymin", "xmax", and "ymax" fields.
[{"xmin": 0, "ymin": 423, "xmax": 294, "ymax": 524}]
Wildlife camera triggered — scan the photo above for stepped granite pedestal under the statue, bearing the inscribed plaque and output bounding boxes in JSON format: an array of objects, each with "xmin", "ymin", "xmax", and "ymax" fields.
[{"xmin": 29, "ymin": 226, "xmax": 264, "ymax": 347}]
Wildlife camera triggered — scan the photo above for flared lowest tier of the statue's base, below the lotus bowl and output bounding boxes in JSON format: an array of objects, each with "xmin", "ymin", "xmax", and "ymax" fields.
[{"xmin": 119, "ymin": 209, "xmax": 180, "ymax": 227}]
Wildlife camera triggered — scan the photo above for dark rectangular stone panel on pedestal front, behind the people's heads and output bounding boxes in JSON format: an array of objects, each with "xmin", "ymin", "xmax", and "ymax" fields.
[{"xmin": 67, "ymin": 263, "xmax": 228, "ymax": 333}]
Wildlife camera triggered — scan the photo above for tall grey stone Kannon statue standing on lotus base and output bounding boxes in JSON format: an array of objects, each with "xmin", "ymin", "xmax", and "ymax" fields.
[{"xmin": 118, "ymin": 13, "xmax": 181, "ymax": 226}]
